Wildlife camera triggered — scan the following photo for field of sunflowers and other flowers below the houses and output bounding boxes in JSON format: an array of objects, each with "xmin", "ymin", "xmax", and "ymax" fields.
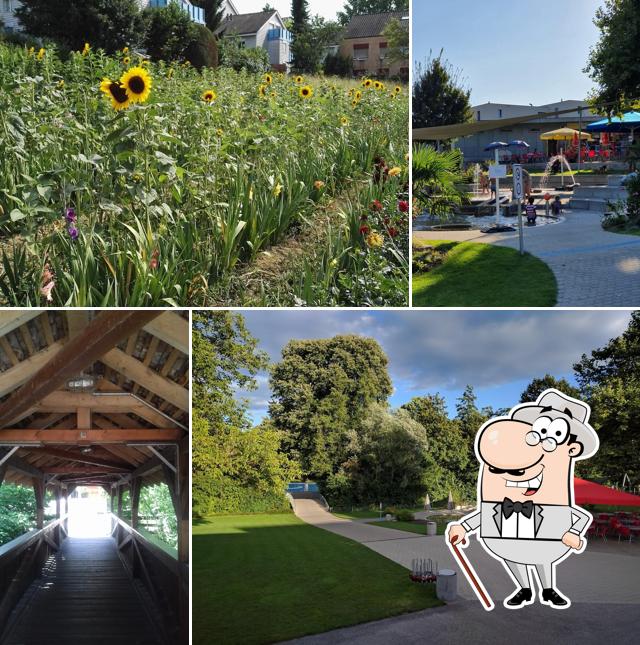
[{"xmin": 0, "ymin": 43, "xmax": 409, "ymax": 306}]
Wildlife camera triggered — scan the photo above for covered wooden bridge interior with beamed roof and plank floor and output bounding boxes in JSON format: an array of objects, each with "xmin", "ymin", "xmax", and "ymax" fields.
[{"xmin": 0, "ymin": 310, "xmax": 189, "ymax": 645}]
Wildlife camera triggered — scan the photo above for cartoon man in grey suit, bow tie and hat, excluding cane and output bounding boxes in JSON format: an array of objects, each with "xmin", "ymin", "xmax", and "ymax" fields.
[{"xmin": 447, "ymin": 389, "xmax": 599, "ymax": 609}]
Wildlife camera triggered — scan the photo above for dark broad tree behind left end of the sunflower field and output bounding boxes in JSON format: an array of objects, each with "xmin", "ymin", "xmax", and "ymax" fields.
[{"xmin": 16, "ymin": 0, "xmax": 146, "ymax": 53}]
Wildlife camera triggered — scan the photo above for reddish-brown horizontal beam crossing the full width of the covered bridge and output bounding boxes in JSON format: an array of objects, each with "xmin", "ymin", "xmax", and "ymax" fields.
[{"xmin": 0, "ymin": 428, "xmax": 185, "ymax": 446}]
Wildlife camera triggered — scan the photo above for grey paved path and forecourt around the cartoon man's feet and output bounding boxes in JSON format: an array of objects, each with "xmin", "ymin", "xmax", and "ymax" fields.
[{"xmin": 295, "ymin": 500, "xmax": 640, "ymax": 645}]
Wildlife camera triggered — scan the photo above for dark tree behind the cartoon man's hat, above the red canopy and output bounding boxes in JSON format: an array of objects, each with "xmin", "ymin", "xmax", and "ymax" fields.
[{"xmin": 574, "ymin": 311, "xmax": 640, "ymax": 485}]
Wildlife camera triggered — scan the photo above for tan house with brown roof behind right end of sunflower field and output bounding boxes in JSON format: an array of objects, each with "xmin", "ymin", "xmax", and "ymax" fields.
[{"xmin": 340, "ymin": 11, "xmax": 409, "ymax": 79}]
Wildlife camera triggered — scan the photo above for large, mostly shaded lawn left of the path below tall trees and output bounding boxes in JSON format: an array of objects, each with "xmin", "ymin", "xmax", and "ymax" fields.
[{"xmin": 193, "ymin": 514, "xmax": 441, "ymax": 645}]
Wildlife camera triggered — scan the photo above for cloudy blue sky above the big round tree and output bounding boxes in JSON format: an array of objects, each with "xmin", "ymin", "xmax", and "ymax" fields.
[{"xmin": 242, "ymin": 309, "xmax": 630, "ymax": 423}]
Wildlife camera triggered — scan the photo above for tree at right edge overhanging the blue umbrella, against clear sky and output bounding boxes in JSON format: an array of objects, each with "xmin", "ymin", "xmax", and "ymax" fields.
[{"xmin": 584, "ymin": 0, "xmax": 640, "ymax": 114}]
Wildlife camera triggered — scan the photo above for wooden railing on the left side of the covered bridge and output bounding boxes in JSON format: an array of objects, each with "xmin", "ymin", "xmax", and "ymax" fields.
[{"xmin": 0, "ymin": 515, "xmax": 68, "ymax": 640}]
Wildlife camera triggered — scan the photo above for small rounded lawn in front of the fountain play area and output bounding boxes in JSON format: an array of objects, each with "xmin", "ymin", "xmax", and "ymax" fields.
[{"xmin": 413, "ymin": 240, "xmax": 557, "ymax": 307}]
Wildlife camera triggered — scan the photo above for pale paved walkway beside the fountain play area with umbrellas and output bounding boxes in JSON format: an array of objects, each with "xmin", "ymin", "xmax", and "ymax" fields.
[{"xmin": 414, "ymin": 211, "xmax": 640, "ymax": 307}]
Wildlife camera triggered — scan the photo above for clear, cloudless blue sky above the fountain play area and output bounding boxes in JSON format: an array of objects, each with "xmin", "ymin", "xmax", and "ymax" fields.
[{"xmin": 413, "ymin": 0, "xmax": 603, "ymax": 105}]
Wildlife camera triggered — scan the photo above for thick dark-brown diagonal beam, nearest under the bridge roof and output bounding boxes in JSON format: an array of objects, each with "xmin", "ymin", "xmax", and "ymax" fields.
[{"xmin": 0, "ymin": 309, "xmax": 161, "ymax": 427}]
